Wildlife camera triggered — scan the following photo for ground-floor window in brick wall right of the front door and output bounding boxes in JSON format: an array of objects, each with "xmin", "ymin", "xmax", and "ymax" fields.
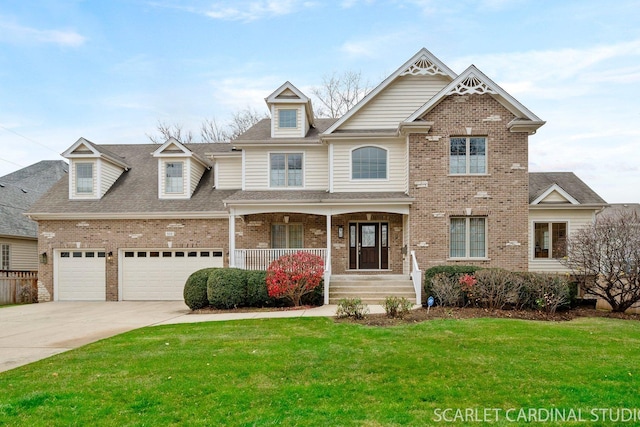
[{"xmin": 449, "ymin": 217, "xmax": 487, "ymax": 258}]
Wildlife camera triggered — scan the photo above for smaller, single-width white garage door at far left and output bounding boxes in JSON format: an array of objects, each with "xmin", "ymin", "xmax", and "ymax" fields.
[{"xmin": 54, "ymin": 249, "xmax": 106, "ymax": 301}]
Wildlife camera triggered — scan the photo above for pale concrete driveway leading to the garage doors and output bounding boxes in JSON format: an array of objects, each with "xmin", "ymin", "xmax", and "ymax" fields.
[{"xmin": 0, "ymin": 301, "xmax": 189, "ymax": 372}]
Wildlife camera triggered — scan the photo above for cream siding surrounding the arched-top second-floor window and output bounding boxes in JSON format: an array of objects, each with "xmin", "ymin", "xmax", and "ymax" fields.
[{"xmin": 333, "ymin": 139, "xmax": 407, "ymax": 193}]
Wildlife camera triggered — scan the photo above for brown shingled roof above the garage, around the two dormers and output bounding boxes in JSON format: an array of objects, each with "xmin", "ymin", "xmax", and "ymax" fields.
[{"xmin": 28, "ymin": 143, "xmax": 237, "ymax": 219}]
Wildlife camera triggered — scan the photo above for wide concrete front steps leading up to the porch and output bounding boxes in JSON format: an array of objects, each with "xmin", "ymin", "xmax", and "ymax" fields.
[{"xmin": 329, "ymin": 275, "xmax": 416, "ymax": 304}]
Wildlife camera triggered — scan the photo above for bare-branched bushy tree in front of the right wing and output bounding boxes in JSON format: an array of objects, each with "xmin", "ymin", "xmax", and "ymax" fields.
[{"xmin": 562, "ymin": 211, "xmax": 640, "ymax": 312}]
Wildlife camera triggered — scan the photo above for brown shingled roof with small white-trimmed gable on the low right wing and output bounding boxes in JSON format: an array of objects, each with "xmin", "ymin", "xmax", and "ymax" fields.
[{"xmin": 529, "ymin": 172, "xmax": 607, "ymax": 206}]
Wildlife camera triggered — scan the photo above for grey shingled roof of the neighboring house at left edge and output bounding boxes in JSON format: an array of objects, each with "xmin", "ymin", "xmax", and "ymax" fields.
[{"xmin": 0, "ymin": 160, "xmax": 69, "ymax": 239}]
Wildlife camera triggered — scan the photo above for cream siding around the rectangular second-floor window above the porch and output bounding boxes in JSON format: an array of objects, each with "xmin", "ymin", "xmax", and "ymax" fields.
[{"xmin": 244, "ymin": 146, "xmax": 329, "ymax": 190}]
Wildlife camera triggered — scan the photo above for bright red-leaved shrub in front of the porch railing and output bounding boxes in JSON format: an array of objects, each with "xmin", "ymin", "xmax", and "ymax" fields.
[{"xmin": 267, "ymin": 251, "xmax": 324, "ymax": 307}]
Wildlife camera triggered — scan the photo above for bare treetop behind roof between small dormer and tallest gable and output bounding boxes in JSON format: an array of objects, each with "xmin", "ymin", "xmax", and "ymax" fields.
[{"xmin": 311, "ymin": 71, "xmax": 371, "ymax": 118}]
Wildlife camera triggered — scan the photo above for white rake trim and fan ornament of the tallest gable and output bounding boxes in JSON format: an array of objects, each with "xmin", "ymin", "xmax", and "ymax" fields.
[{"xmin": 324, "ymin": 48, "xmax": 457, "ymax": 134}]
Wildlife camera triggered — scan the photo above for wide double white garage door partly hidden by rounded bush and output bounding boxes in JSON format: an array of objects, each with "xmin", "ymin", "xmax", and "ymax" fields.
[{"xmin": 120, "ymin": 249, "xmax": 223, "ymax": 301}]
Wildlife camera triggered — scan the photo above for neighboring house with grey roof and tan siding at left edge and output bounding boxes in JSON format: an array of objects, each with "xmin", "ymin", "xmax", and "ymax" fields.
[{"xmin": 0, "ymin": 160, "xmax": 68, "ymax": 271}]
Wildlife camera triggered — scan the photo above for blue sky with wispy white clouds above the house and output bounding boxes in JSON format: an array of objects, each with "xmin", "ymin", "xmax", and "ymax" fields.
[{"xmin": 0, "ymin": 0, "xmax": 640, "ymax": 203}]
